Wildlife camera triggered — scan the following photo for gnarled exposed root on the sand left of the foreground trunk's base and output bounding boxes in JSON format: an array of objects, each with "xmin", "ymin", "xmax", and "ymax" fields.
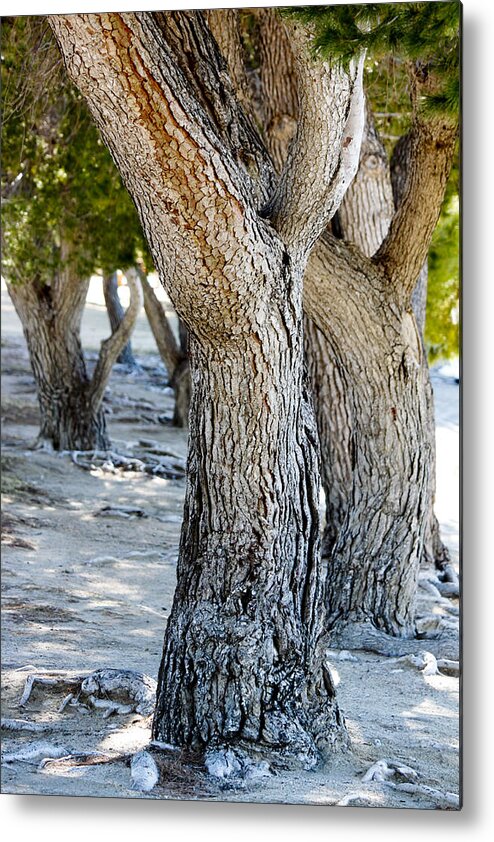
[{"xmin": 19, "ymin": 669, "xmax": 156, "ymax": 718}]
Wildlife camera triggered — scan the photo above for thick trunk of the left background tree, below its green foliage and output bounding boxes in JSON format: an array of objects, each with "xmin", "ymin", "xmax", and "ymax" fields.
[{"xmin": 8, "ymin": 282, "xmax": 108, "ymax": 450}]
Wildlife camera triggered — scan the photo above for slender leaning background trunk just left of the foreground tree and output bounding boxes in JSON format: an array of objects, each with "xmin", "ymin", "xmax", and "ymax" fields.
[{"xmin": 140, "ymin": 272, "xmax": 192, "ymax": 427}]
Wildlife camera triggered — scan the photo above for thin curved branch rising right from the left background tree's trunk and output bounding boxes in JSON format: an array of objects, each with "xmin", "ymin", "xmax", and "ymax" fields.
[{"xmin": 89, "ymin": 269, "xmax": 142, "ymax": 408}]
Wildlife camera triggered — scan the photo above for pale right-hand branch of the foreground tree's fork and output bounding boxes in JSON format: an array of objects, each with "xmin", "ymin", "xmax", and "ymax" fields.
[{"xmin": 263, "ymin": 26, "xmax": 364, "ymax": 252}]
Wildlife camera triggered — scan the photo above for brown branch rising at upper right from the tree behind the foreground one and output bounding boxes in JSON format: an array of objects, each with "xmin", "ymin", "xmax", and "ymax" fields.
[{"xmin": 373, "ymin": 118, "xmax": 458, "ymax": 304}]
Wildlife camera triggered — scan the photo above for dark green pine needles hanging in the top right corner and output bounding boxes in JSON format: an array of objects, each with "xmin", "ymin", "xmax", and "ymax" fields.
[{"xmin": 284, "ymin": 0, "xmax": 461, "ymax": 119}]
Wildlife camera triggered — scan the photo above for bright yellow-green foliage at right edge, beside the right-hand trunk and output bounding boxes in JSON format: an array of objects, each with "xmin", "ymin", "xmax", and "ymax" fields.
[{"xmin": 425, "ymin": 193, "xmax": 460, "ymax": 362}]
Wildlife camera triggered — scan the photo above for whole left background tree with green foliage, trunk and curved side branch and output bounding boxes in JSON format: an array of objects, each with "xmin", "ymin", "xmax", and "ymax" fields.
[{"xmin": 2, "ymin": 17, "xmax": 142, "ymax": 450}]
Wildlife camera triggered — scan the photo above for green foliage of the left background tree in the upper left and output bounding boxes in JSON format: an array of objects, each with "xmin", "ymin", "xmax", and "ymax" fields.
[{"xmin": 1, "ymin": 17, "xmax": 150, "ymax": 285}]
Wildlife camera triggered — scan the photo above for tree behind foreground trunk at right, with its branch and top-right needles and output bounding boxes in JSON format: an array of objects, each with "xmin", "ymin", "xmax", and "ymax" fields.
[{"xmin": 288, "ymin": 3, "xmax": 459, "ymax": 651}]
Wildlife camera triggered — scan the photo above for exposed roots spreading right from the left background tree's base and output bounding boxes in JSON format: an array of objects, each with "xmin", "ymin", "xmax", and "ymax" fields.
[{"xmin": 70, "ymin": 450, "xmax": 185, "ymax": 479}]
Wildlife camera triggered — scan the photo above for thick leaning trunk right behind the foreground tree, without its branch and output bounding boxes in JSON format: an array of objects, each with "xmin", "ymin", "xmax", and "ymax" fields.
[{"xmin": 304, "ymin": 235, "xmax": 431, "ymax": 641}]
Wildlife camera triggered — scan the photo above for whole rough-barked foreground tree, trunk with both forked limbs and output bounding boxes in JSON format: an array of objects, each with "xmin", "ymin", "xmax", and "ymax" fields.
[{"xmin": 50, "ymin": 13, "xmax": 366, "ymax": 765}]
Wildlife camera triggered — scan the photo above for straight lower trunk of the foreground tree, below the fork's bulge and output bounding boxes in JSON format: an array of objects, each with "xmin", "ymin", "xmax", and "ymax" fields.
[{"xmin": 153, "ymin": 324, "xmax": 343, "ymax": 766}]
